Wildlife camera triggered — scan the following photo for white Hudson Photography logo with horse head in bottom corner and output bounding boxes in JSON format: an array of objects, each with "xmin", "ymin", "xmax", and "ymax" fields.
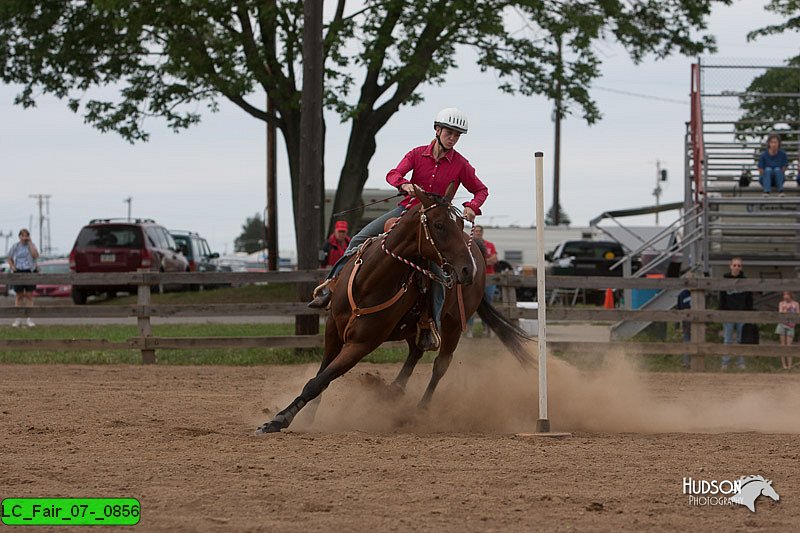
[{"xmin": 683, "ymin": 476, "xmax": 781, "ymax": 513}]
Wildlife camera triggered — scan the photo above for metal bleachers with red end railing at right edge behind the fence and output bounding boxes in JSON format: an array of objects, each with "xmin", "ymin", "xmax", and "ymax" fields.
[{"xmin": 686, "ymin": 61, "xmax": 800, "ymax": 278}]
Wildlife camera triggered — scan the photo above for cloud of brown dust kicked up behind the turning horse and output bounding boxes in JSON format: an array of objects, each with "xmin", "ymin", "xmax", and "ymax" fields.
[{"xmin": 270, "ymin": 341, "xmax": 800, "ymax": 433}]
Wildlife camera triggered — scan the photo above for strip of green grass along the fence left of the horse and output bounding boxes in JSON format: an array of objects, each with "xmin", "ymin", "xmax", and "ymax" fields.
[{"xmin": 0, "ymin": 324, "xmax": 424, "ymax": 366}]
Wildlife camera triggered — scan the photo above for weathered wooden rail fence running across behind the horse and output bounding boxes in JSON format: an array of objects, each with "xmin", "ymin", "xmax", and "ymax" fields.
[{"xmin": 0, "ymin": 271, "xmax": 800, "ymax": 369}]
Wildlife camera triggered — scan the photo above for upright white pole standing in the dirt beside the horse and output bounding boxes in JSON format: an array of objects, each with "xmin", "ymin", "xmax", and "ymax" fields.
[{"xmin": 535, "ymin": 152, "xmax": 558, "ymax": 433}]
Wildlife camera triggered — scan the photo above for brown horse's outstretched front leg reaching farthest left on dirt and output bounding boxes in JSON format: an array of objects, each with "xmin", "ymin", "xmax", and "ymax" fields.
[{"xmin": 256, "ymin": 343, "xmax": 377, "ymax": 435}]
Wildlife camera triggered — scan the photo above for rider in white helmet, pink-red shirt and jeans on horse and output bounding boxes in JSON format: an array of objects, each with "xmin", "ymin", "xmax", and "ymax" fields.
[{"xmin": 308, "ymin": 107, "xmax": 489, "ymax": 344}]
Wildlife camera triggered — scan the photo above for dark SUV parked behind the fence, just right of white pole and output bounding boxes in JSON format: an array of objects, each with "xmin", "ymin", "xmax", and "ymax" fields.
[{"xmin": 545, "ymin": 241, "xmax": 625, "ymax": 276}]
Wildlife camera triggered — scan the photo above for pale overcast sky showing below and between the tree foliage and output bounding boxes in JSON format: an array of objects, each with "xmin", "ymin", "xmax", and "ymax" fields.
[{"xmin": 0, "ymin": 0, "xmax": 800, "ymax": 255}]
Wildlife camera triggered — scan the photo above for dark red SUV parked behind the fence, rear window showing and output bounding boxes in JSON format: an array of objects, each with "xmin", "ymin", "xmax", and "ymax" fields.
[{"xmin": 69, "ymin": 218, "xmax": 189, "ymax": 305}]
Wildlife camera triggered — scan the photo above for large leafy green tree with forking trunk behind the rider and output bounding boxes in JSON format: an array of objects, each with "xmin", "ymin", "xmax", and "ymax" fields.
[{"xmin": 0, "ymin": 0, "xmax": 730, "ymax": 249}]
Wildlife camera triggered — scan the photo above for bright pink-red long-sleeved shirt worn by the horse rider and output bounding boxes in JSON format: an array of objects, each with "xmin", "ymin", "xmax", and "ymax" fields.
[{"xmin": 386, "ymin": 141, "xmax": 489, "ymax": 215}]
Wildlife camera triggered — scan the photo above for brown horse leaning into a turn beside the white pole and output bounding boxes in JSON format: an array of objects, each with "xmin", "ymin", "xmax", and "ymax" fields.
[{"xmin": 256, "ymin": 183, "xmax": 532, "ymax": 435}]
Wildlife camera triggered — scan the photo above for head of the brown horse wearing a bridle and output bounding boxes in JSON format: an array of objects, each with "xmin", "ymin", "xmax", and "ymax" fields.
[{"xmin": 414, "ymin": 183, "xmax": 476, "ymax": 285}]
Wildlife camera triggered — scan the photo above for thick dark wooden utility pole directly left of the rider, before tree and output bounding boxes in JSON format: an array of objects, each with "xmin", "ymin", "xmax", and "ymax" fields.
[{"xmin": 295, "ymin": 0, "xmax": 323, "ymax": 335}]
